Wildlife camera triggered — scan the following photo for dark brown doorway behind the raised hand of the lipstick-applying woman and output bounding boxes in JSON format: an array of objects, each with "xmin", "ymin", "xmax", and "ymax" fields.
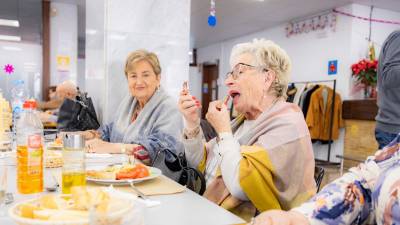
[{"xmin": 201, "ymin": 63, "xmax": 218, "ymax": 119}]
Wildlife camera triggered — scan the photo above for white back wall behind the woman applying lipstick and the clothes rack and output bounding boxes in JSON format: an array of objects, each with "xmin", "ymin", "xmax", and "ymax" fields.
[{"xmin": 195, "ymin": 4, "xmax": 400, "ymax": 161}]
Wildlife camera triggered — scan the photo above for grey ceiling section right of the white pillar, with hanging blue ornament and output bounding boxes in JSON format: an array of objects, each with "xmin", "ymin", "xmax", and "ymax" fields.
[{"xmin": 190, "ymin": 0, "xmax": 400, "ymax": 48}]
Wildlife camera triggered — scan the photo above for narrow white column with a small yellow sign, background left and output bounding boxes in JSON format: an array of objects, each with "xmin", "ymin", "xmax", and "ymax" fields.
[{"xmin": 50, "ymin": 2, "xmax": 78, "ymax": 85}]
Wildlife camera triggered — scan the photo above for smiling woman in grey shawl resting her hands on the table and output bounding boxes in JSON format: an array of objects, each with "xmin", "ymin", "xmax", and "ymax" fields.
[{"xmin": 84, "ymin": 50, "xmax": 183, "ymax": 163}]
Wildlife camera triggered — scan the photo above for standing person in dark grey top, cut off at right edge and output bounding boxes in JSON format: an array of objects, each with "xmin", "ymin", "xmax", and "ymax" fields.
[{"xmin": 375, "ymin": 30, "xmax": 400, "ymax": 149}]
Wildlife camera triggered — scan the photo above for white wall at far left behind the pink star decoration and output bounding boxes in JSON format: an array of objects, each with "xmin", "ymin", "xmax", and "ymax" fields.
[{"xmin": 0, "ymin": 41, "xmax": 42, "ymax": 100}]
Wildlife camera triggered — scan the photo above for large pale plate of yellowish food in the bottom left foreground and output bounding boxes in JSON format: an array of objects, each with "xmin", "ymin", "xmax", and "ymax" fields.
[{"xmin": 8, "ymin": 187, "xmax": 140, "ymax": 225}]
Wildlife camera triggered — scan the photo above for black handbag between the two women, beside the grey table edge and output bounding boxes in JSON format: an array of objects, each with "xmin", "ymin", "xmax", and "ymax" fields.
[{"xmin": 152, "ymin": 148, "xmax": 206, "ymax": 195}]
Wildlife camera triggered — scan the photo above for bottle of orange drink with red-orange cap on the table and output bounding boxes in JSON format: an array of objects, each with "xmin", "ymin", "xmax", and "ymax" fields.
[{"xmin": 16, "ymin": 100, "xmax": 43, "ymax": 194}]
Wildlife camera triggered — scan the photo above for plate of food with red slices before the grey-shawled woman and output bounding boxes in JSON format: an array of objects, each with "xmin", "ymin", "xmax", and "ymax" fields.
[{"xmin": 86, "ymin": 163, "xmax": 162, "ymax": 185}]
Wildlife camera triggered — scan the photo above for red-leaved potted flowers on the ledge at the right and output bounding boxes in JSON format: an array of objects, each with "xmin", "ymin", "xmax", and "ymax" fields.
[{"xmin": 351, "ymin": 59, "xmax": 378, "ymax": 86}]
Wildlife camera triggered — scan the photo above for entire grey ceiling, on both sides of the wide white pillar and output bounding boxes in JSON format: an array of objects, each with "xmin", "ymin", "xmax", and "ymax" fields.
[{"xmin": 0, "ymin": 0, "xmax": 400, "ymax": 51}]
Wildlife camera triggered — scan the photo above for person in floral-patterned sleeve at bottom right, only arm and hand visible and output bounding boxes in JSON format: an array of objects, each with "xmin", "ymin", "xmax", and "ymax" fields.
[{"xmin": 251, "ymin": 134, "xmax": 400, "ymax": 225}]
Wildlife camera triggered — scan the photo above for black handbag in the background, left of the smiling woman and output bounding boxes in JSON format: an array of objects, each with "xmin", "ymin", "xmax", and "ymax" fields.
[{"xmin": 57, "ymin": 92, "xmax": 100, "ymax": 131}]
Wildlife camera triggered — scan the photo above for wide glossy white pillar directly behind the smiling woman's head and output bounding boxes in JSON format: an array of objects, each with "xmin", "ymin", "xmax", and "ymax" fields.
[{"xmin": 86, "ymin": 0, "xmax": 190, "ymax": 122}]
